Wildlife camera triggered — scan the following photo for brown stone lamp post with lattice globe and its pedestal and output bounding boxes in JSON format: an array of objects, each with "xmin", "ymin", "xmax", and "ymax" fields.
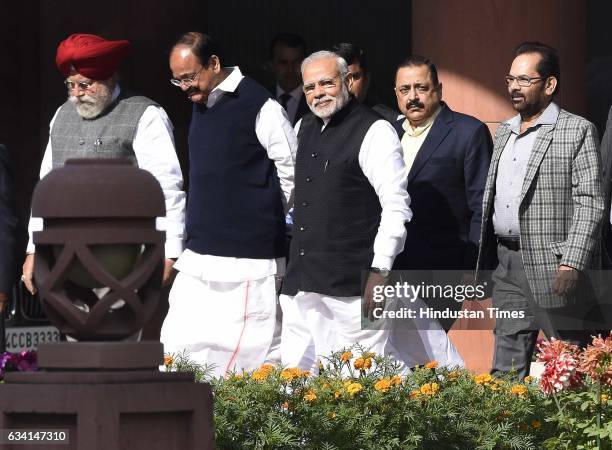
[{"xmin": 0, "ymin": 159, "xmax": 213, "ymax": 450}]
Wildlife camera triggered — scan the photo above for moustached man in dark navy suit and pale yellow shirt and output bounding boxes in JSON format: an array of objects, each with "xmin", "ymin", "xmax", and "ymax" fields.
[{"xmin": 394, "ymin": 56, "xmax": 492, "ymax": 330}]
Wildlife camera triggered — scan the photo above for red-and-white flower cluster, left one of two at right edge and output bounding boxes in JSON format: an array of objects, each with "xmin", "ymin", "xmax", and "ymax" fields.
[{"xmin": 538, "ymin": 338, "xmax": 582, "ymax": 395}]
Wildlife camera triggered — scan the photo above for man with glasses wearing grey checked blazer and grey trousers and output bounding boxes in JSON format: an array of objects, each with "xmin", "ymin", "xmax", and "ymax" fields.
[{"xmin": 479, "ymin": 42, "xmax": 604, "ymax": 378}]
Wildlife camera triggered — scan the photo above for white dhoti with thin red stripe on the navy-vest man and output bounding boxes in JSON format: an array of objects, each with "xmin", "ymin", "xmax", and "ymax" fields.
[{"xmin": 161, "ymin": 272, "xmax": 280, "ymax": 377}]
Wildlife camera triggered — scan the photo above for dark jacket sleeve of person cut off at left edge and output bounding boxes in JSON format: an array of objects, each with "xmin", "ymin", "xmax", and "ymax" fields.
[{"xmin": 0, "ymin": 144, "xmax": 17, "ymax": 293}]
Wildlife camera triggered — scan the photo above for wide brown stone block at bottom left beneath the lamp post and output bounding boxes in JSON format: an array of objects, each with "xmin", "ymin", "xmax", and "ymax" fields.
[{"xmin": 0, "ymin": 371, "xmax": 214, "ymax": 450}]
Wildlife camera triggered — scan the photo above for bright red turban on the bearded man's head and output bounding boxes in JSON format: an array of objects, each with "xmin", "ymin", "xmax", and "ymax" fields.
[{"xmin": 55, "ymin": 34, "xmax": 130, "ymax": 80}]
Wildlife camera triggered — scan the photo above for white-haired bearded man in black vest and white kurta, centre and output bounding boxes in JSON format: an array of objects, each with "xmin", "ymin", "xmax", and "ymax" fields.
[{"xmin": 280, "ymin": 51, "xmax": 411, "ymax": 370}]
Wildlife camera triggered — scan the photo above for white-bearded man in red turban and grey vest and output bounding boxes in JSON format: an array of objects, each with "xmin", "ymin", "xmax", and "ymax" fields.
[{"xmin": 22, "ymin": 34, "xmax": 185, "ymax": 338}]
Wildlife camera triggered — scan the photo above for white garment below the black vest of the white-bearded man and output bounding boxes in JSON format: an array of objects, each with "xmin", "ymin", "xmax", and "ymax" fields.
[{"xmin": 280, "ymin": 291, "xmax": 389, "ymax": 373}]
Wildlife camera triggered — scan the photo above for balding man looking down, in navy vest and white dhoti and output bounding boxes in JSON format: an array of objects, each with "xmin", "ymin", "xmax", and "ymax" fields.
[{"xmin": 162, "ymin": 32, "xmax": 297, "ymax": 376}]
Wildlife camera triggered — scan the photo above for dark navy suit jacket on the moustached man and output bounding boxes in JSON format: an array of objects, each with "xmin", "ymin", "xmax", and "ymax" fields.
[{"xmin": 394, "ymin": 103, "xmax": 493, "ymax": 271}]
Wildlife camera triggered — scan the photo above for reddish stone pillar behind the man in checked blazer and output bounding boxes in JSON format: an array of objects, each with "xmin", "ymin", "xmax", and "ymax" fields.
[{"xmin": 412, "ymin": 0, "xmax": 587, "ymax": 371}]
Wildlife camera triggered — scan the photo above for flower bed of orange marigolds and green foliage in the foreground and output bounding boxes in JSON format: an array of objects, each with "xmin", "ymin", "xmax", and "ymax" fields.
[{"xmin": 166, "ymin": 337, "xmax": 612, "ymax": 450}]
